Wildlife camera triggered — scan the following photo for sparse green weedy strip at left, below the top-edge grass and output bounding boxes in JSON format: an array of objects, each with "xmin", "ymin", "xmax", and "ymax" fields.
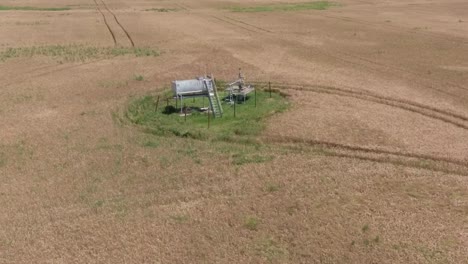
[{"xmin": 0, "ymin": 44, "xmax": 160, "ymax": 62}]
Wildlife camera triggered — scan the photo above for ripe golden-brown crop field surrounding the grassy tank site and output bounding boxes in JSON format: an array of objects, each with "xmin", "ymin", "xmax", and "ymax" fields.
[{"xmin": 0, "ymin": 0, "xmax": 468, "ymax": 263}]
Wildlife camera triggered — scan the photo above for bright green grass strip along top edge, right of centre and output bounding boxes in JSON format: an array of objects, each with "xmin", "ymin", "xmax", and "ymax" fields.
[{"xmin": 229, "ymin": 1, "xmax": 337, "ymax": 12}]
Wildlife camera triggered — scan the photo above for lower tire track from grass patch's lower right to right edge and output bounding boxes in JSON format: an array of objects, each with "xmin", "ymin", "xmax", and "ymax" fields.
[{"xmin": 263, "ymin": 136, "xmax": 468, "ymax": 176}]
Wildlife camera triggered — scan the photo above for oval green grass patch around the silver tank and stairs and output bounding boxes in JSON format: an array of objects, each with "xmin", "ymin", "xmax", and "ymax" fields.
[{"xmin": 126, "ymin": 87, "xmax": 289, "ymax": 141}]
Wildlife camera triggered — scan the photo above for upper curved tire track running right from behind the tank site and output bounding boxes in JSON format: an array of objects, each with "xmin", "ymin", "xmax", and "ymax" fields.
[{"xmin": 254, "ymin": 82, "xmax": 468, "ymax": 131}]
